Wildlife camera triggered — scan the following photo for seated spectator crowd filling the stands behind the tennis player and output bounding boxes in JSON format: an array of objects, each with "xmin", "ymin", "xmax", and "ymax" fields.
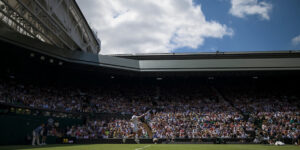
[{"xmin": 0, "ymin": 78, "xmax": 300, "ymax": 142}]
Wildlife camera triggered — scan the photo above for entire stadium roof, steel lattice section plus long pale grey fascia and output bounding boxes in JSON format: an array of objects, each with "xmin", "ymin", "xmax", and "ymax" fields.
[{"xmin": 0, "ymin": 0, "xmax": 300, "ymax": 74}]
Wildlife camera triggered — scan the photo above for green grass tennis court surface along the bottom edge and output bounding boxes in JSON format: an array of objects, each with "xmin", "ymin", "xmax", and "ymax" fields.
[{"xmin": 0, "ymin": 144, "xmax": 300, "ymax": 150}]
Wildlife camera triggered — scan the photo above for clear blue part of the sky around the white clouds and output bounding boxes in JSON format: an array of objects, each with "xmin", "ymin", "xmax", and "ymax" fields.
[{"xmin": 174, "ymin": 0, "xmax": 300, "ymax": 52}]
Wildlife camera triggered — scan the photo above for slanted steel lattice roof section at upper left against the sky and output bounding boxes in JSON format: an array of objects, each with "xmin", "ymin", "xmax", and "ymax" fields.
[{"xmin": 0, "ymin": 0, "xmax": 101, "ymax": 54}]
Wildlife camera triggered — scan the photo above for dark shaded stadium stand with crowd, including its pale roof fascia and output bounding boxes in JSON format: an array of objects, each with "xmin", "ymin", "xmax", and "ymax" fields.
[{"xmin": 0, "ymin": 1, "xmax": 300, "ymax": 145}]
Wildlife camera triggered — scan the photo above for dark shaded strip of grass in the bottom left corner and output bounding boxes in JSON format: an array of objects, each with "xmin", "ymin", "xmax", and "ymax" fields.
[{"xmin": 0, "ymin": 144, "xmax": 93, "ymax": 150}]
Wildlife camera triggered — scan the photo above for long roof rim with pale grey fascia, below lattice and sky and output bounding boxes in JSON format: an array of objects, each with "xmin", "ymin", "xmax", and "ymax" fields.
[{"xmin": 0, "ymin": 21, "xmax": 300, "ymax": 73}]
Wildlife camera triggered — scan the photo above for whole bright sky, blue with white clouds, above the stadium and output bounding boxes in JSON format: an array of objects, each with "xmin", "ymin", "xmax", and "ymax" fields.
[{"xmin": 77, "ymin": 0, "xmax": 300, "ymax": 54}]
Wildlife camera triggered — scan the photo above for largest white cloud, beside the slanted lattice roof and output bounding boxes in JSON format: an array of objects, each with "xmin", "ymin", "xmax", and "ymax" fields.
[{"xmin": 77, "ymin": 0, "xmax": 233, "ymax": 54}]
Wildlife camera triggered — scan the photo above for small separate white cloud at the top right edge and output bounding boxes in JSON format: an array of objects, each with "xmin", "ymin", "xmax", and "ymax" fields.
[{"xmin": 229, "ymin": 0, "xmax": 272, "ymax": 20}]
